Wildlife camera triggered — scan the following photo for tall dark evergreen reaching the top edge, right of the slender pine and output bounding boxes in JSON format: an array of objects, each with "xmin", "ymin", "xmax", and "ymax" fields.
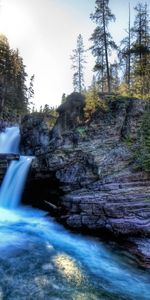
[{"xmin": 90, "ymin": 0, "xmax": 117, "ymax": 93}]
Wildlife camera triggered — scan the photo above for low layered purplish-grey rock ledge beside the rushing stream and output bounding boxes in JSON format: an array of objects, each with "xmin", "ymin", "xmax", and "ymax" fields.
[{"xmin": 63, "ymin": 171, "xmax": 150, "ymax": 237}]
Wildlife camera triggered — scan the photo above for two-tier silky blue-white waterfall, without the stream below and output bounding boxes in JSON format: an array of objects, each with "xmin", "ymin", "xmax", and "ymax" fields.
[{"xmin": 0, "ymin": 127, "xmax": 32, "ymax": 209}]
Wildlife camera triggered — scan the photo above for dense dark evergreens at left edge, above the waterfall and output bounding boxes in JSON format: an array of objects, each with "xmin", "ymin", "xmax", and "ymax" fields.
[{"xmin": 0, "ymin": 34, "xmax": 33, "ymax": 121}]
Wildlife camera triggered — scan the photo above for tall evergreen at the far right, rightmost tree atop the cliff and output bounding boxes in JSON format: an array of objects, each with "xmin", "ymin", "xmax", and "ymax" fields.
[{"xmin": 131, "ymin": 3, "xmax": 150, "ymax": 98}]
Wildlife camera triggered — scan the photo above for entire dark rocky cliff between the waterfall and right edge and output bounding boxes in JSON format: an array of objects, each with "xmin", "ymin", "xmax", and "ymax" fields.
[{"xmin": 22, "ymin": 95, "xmax": 150, "ymax": 266}]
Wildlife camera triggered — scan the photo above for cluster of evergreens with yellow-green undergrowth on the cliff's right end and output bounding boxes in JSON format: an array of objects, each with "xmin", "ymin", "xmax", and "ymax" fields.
[{"xmin": 119, "ymin": 2, "xmax": 150, "ymax": 100}]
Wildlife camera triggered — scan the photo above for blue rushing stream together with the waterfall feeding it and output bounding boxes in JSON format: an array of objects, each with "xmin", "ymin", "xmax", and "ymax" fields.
[{"xmin": 0, "ymin": 127, "xmax": 150, "ymax": 300}]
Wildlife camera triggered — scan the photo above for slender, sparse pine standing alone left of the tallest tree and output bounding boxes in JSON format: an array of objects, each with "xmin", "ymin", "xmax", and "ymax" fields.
[{"xmin": 71, "ymin": 34, "xmax": 86, "ymax": 93}]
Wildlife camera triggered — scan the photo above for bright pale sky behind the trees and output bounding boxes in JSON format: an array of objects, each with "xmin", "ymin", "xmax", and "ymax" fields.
[{"xmin": 0, "ymin": 0, "xmax": 146, "ymax": 107}]
